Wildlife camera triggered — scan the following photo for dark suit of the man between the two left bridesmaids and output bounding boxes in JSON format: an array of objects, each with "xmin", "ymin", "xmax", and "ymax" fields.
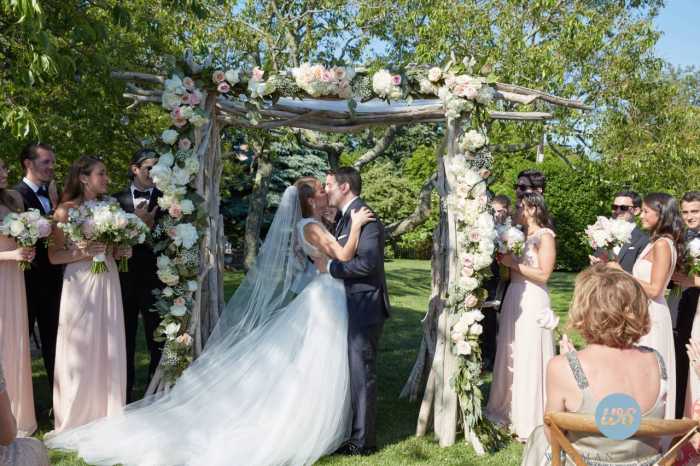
[{"xmin": 15, "ymin": 181, "xmax": 64, "ymax": 389}]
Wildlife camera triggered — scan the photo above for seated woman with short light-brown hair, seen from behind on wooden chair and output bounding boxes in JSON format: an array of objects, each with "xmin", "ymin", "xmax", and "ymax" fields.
[{"xmin": 522, "ymin": 265, "xmax": 667, "ymax": 466}]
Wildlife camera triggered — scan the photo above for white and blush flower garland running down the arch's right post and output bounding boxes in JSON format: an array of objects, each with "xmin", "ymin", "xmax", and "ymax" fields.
[{"xmin": 444, "ymin": 130, "xmax": 507, "ymax": 449}]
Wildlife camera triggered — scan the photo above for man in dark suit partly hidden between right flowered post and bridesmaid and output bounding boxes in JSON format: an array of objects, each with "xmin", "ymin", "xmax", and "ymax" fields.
[{"xmin": 481, "ymin": 194, "xmax": 510, "ymax": 371}]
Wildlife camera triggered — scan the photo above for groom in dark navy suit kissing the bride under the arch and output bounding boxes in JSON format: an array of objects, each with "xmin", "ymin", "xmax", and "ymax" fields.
[{"xmin": 326, "ymin": 167, "xmax": 390, "ymax": 455}]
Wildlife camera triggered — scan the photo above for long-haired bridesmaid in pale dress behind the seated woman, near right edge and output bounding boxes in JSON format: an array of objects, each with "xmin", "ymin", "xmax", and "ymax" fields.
[{"xmin": 608, "ymin": 193, "xmax": 684, "ymax": 419}]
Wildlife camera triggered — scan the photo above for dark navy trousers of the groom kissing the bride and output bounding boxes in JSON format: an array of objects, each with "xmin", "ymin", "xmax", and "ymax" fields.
[{"xmin": 348, "ymin": 321, "xmax": 384, "ymax": 448}]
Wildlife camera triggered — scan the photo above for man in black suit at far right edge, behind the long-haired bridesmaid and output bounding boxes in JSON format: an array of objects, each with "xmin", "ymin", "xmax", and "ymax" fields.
[{"xmin": 672, "ymin": 191, "xmax": 700, "ymax": 419}]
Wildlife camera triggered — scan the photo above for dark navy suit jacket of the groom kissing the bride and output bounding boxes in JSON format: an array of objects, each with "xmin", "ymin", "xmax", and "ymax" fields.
[{"xmin": 329, "ymin": 198, "xmax": 391, "ymax": 329}]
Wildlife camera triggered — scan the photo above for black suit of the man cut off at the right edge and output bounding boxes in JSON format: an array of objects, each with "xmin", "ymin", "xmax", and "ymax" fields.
[{"xmin": 673, "ymin": 230, "xmax": 700, "ymax": 419}]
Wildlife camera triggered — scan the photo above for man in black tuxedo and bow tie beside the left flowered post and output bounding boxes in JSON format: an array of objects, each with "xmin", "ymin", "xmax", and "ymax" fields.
[{"xmin": 114, "ymin": 149, "xmax": 163, "ymax": 403}]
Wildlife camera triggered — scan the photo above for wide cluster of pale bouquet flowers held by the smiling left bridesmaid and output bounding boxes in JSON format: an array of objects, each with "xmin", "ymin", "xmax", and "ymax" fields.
[{"xmin": 58, "ymin": 199, "xmax": 148, "ymax": 273}]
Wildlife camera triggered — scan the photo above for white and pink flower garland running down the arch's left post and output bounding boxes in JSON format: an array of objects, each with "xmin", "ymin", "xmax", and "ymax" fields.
[{"xmin": 151, "ymin": 75, "xmax": 209, "ymax": 382}]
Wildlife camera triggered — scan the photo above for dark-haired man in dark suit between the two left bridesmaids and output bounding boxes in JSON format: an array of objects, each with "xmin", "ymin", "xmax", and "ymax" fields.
[{"xmin": 15, "ymin": 142, "xmax": 63, "ymax": 391}]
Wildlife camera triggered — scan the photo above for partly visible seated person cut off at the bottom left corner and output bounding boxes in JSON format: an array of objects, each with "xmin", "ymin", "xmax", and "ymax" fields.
[{"xmin": 0, "ymin": 366, "xmax": 49, "ymax": 466}]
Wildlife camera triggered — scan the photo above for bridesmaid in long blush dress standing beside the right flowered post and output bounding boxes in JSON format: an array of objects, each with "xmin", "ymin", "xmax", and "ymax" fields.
[{"xmin": 486, "ymin": 192, "xmax": 558, "ymax": 442}]
